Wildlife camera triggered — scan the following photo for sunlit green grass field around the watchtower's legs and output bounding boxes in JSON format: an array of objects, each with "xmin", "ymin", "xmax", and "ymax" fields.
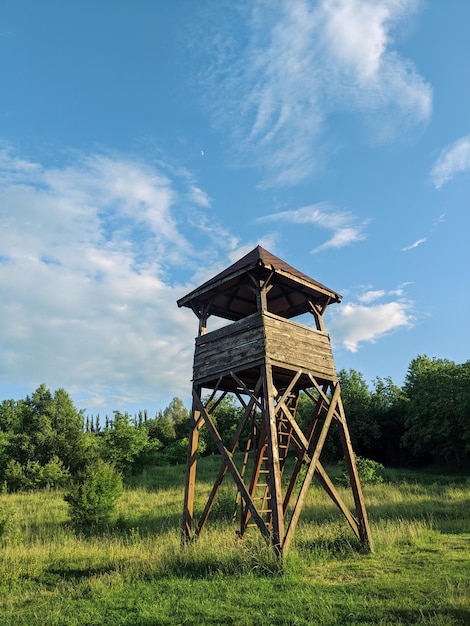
[{"xmin": 0, "ymin": 459, "xmax": 470, "ymax": 626}]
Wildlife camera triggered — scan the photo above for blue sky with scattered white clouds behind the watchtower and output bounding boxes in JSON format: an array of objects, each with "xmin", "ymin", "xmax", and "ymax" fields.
[{"xmin": 0, "ymin": 0, "xmax": 470, "ymax": 415}]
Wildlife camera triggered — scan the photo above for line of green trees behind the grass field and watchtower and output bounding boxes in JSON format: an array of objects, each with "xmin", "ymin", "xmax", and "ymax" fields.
[{"xmin": 0, "ymin": 355, "xmax": 470, "ymax": 492}]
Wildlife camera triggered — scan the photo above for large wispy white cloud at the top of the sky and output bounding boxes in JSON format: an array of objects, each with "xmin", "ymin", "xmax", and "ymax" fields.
[{"xmin": 200, "ymin": 0, "xmax": 432, "ymax": 186}]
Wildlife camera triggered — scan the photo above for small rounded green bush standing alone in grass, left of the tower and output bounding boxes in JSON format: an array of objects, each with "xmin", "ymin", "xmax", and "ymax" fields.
[{"xmin": 64, "ymin": 460, "xmax": 122, "ymax": 527}]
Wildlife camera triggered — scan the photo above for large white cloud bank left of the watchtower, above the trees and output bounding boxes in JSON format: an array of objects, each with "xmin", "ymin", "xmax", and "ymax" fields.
[{"xmin": 0, "ymin": 144, "xmax": 235, "ymax": 412}]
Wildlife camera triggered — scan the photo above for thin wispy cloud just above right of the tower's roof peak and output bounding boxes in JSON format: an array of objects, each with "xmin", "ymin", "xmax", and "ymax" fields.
[{"xmin": 256, "ymin": 202, "xmax": 368, "ymax": 253}]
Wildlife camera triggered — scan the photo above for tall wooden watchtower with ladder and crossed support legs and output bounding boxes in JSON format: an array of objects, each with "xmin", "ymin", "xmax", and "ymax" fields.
[{"xmin": 178, "ymin": 246, "xmax": 372, "ymax": 555}]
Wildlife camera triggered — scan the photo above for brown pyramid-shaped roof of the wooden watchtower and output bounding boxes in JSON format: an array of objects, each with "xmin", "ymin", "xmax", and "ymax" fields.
[{"xmin": 177, "ymin": 246, "xmax": 342, "ymax": 321}]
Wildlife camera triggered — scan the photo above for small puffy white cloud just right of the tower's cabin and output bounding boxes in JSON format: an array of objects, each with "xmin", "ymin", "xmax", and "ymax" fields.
[{"xmin": 328, "ymin": 288, "xmax": 414, "ymax": 352}]
